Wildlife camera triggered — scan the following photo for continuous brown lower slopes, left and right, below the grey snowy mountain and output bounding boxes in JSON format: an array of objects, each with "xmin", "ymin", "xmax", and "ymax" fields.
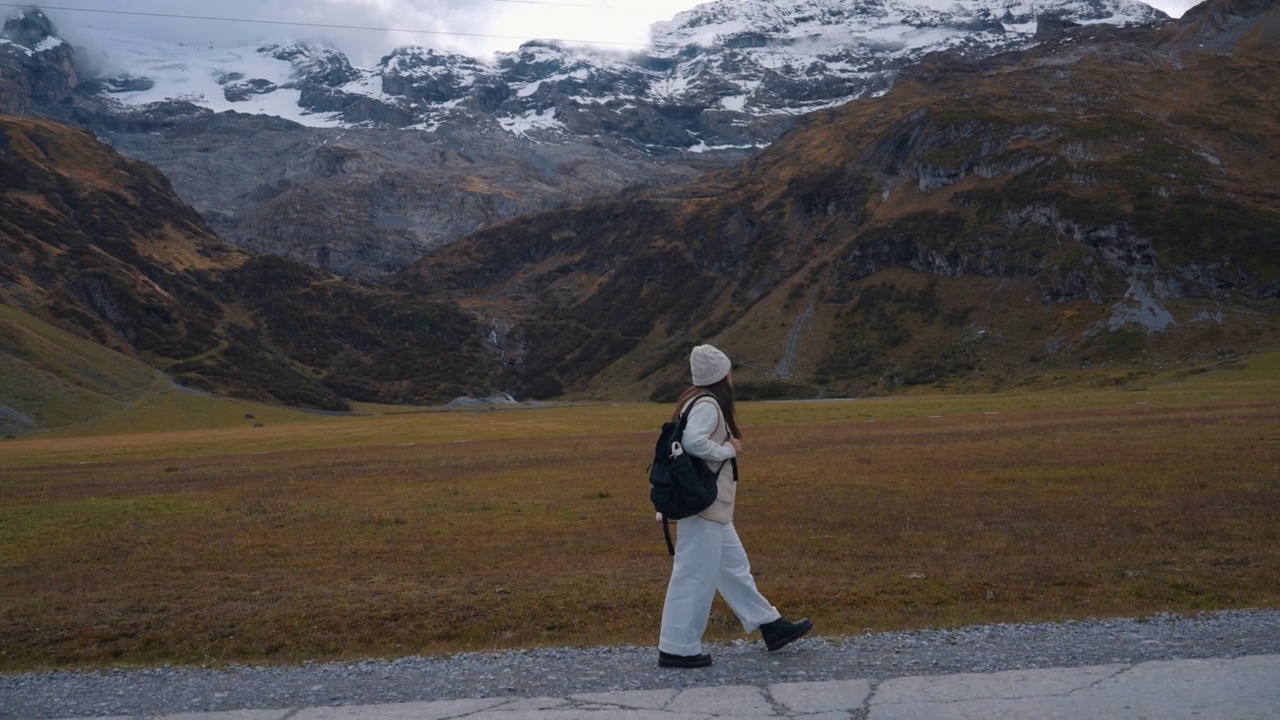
[{"xmin": 0, "ymin": 0, "xmax": 1280, "ymax": 427}]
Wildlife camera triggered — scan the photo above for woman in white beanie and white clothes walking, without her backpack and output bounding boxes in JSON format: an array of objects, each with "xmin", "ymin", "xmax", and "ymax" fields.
[{"xmin": 658, "ymin": 345, "xmax": 813, "ymax": 667}]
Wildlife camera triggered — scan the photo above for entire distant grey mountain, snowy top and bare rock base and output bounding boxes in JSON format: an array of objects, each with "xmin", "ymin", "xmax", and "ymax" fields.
[{"xmin": 0, "ymin": 0, "xmax": 1162, "ymax": 279}]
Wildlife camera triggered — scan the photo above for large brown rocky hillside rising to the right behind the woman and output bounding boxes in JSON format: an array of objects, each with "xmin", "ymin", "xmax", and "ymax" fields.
[{"xmin": 396, "ymin": 0, "xmax": 1280, "ymax": 397}]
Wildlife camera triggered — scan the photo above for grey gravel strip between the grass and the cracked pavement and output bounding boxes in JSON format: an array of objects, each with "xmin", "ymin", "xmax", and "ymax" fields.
[{"xmin": 0, "ymin": 610, "xmax": 1280, "ymax": 720}]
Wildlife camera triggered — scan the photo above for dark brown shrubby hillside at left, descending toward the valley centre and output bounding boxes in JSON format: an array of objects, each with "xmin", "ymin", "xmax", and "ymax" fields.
[{"xmin": 0, "ymin": 117, "xmax": 502, "ymax": 418}]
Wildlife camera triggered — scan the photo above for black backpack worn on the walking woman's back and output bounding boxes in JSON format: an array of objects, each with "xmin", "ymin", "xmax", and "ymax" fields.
[{"xmin": 649, "ymin": 395, "xmax": 717, "ymax": 555}]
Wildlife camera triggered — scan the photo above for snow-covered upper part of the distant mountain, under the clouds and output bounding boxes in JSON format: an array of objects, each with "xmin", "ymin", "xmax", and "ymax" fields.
[{"xmin": 40, "ymin": 0, "xmax": 1164, "ymax": 146}]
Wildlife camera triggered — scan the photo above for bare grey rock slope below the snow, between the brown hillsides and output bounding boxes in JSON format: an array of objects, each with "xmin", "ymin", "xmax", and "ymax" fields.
[{"xmin": 101, "ymin": 108, "xmax": 718, "ymax": 281}]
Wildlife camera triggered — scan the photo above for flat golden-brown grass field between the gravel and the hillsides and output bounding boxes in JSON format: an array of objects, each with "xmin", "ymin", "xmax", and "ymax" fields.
[{"xmin": 0, "ymin": 354, "xmax": 1280, "ymax": 671}]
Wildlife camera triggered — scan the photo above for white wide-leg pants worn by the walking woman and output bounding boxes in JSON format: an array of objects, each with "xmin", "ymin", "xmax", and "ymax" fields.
[{"xmin": 658, "ymin": 516, "xmax": 782, "ymax": 655}]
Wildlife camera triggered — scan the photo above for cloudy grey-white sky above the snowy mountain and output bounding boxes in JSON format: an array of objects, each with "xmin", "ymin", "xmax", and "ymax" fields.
[{"xmin": 40, "ymin": 0, "xmax": 1196, "ymax": 65}]
